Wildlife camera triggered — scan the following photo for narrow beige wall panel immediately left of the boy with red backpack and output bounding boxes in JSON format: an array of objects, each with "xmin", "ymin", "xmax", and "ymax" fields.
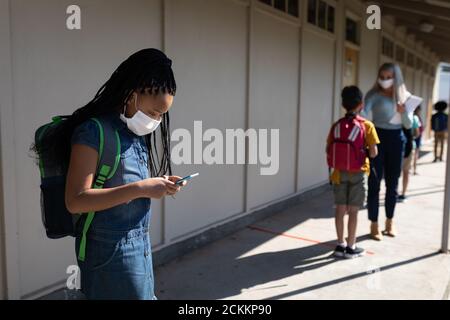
[{"xmin": 298, "ymin": 26, "xmax": 334, "ymax": 190}]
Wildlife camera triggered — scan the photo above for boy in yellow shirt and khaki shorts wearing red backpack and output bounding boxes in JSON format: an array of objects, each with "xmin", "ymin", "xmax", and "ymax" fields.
[{"xmin": 326, "ymin": 86, "xmax": 380, "ymax": 259}]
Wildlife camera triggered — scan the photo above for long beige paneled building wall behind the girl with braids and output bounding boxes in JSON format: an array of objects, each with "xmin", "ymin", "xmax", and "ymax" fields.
[{"xmin": 0, "ymin": 0, "xmax": 442, "ymax": 299}]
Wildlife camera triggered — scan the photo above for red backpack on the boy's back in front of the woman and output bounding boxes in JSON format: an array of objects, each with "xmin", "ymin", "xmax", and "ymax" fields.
[{"xmin": 327, "ymin": 116, "xmax": 366, "ymax": 172}]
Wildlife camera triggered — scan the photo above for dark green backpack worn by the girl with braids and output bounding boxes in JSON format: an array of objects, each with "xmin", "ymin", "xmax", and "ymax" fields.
[{"xmin": 35, "ymin": 116, "xmax": 120, "ymax": 261}]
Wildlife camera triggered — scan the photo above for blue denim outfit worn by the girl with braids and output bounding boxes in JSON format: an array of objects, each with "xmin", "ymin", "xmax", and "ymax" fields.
[{"xmin": 71, "ymin": 113, "xmax": 156, "ymax": 300}]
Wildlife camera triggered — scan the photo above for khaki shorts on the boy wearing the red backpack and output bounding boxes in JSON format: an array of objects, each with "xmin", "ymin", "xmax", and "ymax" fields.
[{"xmin": 333, "ymin": 171, "xmax": 366, "ymax": 208}]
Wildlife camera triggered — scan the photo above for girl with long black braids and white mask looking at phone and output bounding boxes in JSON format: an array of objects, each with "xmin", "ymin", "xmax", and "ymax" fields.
[{"xmin": 34, "ymin": 49, "xmax": 186, "ymax": 300}]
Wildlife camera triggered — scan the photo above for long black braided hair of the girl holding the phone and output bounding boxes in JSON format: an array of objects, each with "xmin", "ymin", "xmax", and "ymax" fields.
[{"xmin": 31, "ymin": 49, "xmax": 176, "ymax": 177}]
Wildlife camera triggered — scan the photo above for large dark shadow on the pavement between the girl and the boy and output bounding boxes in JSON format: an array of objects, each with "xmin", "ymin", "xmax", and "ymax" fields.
[{"xmin": 155, "ymin": 192, "xmax": 376, "ymax": 300}]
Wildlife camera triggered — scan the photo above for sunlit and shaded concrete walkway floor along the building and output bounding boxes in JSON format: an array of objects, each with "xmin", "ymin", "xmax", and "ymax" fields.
[{"xmin": 155, "ymin": 148, "xmax": 450, "ymax": 300}]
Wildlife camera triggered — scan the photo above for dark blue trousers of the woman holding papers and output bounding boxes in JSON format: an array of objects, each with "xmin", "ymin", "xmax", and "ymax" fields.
[{"xmin": 367, "ymin": 128, "xmax": 406, "ymax": 222}]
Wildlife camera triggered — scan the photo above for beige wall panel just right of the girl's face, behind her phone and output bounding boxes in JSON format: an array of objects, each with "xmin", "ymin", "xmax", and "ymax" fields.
[{"xmin": 164, "ymin": 0, "xmax": 248, "ymax": 240}]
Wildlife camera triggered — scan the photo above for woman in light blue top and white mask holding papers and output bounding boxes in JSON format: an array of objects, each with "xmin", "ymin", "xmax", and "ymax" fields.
[{"xmin": 363, "ymin": 63, "xmax": 413, "ymax": 241}]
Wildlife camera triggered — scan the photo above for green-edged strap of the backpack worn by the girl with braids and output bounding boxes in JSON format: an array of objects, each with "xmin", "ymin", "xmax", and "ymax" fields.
[{"xmin": 78, "ymin": 118, "xmax": 120, "ymax": 261}]
